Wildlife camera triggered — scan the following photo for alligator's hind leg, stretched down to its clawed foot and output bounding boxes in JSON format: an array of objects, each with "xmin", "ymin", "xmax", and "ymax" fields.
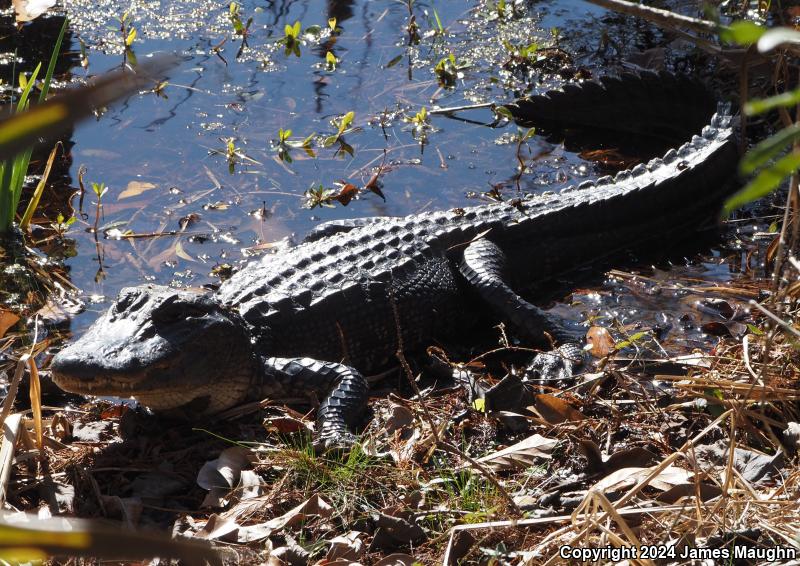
[{"xmin": 460, "ymin": 238, "xmax": 585, "ymax": 382}]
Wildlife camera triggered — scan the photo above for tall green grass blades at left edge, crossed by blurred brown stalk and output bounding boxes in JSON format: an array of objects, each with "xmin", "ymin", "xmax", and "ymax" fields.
[{"xmin": 0, "ymin": 19, "xmax": 68, "ymax": 234}]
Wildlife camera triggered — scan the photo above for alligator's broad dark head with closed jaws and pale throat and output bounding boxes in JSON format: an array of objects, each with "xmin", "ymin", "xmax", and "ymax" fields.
[{"xmin": 51, "ymin": 285, "xmax": 257, "ymax": 414}]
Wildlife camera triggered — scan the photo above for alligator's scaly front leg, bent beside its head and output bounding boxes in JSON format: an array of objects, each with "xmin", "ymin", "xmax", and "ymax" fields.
[{"xmin": 261, "ymin": 358, "xmax": 369, "ymax": 448}]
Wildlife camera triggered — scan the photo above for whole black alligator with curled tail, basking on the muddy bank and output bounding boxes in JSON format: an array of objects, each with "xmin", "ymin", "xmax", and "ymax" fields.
[{"xmin": 51, "ymin": 73, "xmax": 738, "ymax": 444}]
